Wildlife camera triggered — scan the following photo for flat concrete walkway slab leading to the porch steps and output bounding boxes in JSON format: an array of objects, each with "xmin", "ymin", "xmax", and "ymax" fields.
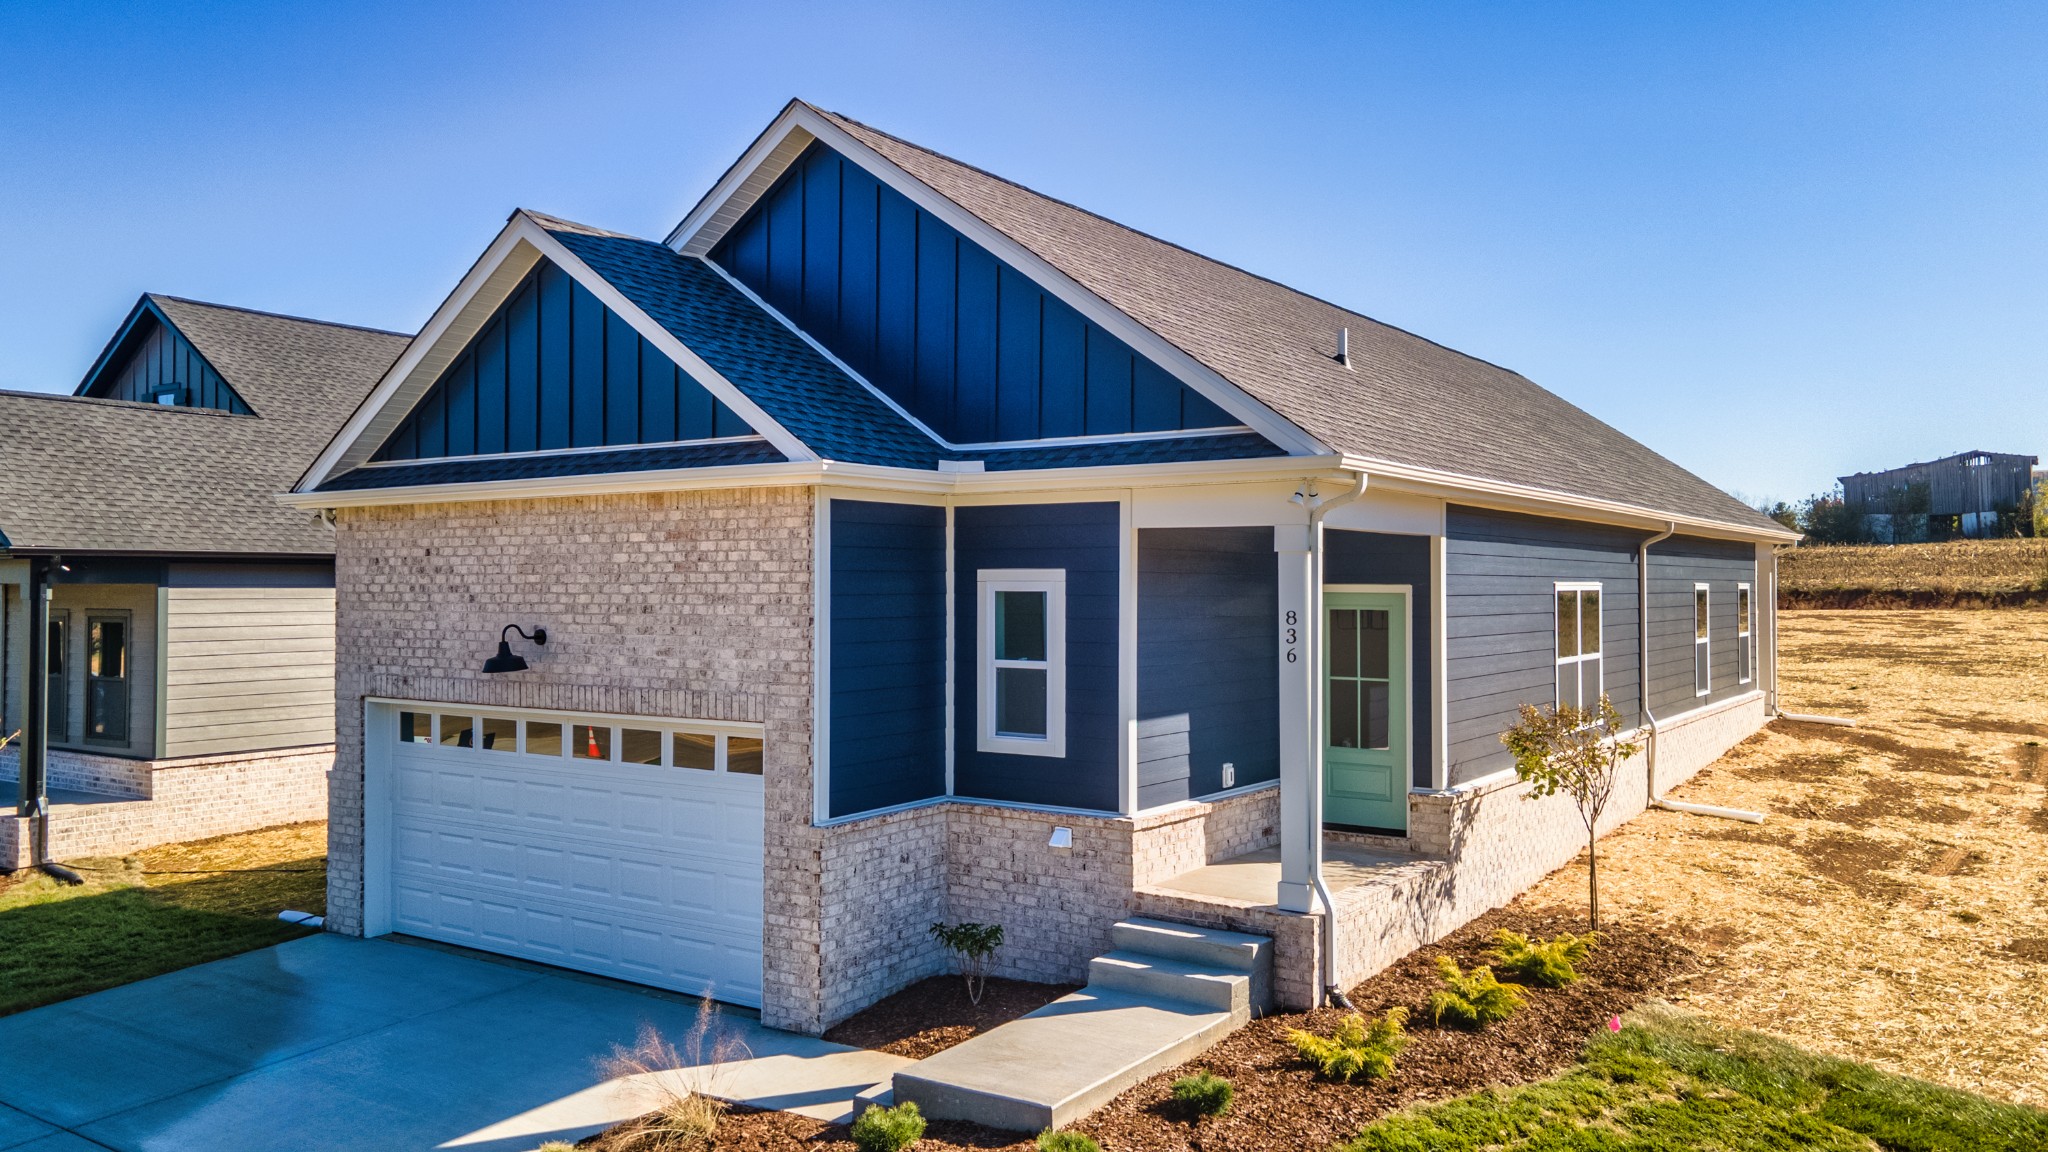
[{"xmin": 895, "ymin": 974, "xmax": 1249, "ymax": 1132}]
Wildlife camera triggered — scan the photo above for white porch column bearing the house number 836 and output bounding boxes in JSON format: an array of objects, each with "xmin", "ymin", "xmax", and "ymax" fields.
[{"xmin": 1274, "ymin": 525, "xmax": 1323, "ymax": 912}]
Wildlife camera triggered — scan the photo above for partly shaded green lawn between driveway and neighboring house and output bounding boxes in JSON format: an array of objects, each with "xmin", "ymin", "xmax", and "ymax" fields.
[{"xmin": 0, "ymin": 824, "xmax": 328, "ymax": 1015}]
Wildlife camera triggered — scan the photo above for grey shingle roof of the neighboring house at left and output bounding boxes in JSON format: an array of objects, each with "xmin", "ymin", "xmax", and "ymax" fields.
[{"xmin": 0, "ymin": 295, "xmax": 410, "ymax": 556}]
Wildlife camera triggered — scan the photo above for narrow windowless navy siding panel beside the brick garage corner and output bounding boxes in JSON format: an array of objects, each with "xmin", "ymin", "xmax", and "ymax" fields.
[{"xmin": 827, "ymin": 500, "xmax": 946, "ymax": 818}]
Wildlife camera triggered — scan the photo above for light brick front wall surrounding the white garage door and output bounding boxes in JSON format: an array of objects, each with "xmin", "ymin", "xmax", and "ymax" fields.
[{"xmin": 328, "ymin": 488, "xmax": 825, "ymax": 1033}]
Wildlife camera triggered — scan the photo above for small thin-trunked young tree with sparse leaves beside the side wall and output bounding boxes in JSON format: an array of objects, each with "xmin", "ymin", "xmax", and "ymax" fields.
[{"xmin": 1501, "ymin": 693, "xmax": 1642, "ymax": 931}]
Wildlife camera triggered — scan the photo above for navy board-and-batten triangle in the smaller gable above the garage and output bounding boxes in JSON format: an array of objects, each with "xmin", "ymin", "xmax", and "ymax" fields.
[{"xmin": 373, "ymin": 260, "xmax": 754, "ymax": 461}]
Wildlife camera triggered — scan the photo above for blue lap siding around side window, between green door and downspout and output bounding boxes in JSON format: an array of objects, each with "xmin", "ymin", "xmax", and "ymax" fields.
[{"xmin": 1444, "ymin": 506, "xmax": 1651, "ymax": 785}]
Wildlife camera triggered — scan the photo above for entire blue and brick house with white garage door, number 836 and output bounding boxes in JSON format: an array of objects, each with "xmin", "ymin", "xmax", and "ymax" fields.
[{"xmin": 289, "ymin": 102, "xmax": 1796, "ymax": 1031}]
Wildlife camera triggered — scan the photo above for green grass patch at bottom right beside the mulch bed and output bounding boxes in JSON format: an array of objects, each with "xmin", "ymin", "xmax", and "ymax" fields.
[{"xmin": 1339, "ymin": 1009, "xmax": 2048, "ymax": 1152}]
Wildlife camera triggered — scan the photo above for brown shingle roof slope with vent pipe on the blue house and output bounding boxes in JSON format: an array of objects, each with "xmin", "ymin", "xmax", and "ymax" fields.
[{"xmin": 815, "ymin": 109, "xmax": 1780, "ymax": 531}]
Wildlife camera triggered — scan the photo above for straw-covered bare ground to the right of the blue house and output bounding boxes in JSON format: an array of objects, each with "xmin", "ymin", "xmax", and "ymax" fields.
[{"xmin": 1528, "ymin": 611, "xmax": 2048, "ymax": 1105}]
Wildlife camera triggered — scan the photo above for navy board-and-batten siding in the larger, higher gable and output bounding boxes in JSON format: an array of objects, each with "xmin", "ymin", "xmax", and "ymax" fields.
[{"xmin": 711, "ymin": 134, "xmax": 1237, "ymax": 443}]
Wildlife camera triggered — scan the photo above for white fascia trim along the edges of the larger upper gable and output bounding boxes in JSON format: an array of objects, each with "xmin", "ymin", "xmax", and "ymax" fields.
[{"xmin": 668, "ymin": 102, "xmax": 1329, "ymax": 455}]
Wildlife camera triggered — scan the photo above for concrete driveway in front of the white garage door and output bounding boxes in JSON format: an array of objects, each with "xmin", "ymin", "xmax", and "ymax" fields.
[{"xmin": 0, "ymin": 935, "xmax": 907, "ymax": 1152}]
